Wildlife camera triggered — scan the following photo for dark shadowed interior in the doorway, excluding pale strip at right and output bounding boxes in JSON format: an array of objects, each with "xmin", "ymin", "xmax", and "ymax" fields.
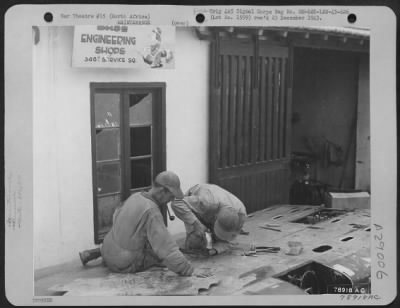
[{"xmin": 291, "ymin": 47, "xmax": 360, "ymax": 189}]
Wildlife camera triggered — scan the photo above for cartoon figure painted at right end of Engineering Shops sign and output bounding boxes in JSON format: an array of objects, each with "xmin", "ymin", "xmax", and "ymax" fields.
[{"xmin": 143, "ymin": 27, "xmax": 174, "ymax": 68}]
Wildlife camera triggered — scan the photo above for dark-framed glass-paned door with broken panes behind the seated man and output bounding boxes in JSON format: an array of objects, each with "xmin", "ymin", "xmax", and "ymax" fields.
[{"xmin": 90, "ymin": 83, "xmax": 166, "ymax": 244}]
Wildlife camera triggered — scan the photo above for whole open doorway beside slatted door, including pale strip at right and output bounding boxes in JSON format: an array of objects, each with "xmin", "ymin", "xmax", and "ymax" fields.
[{"xmin": 291, "ymin": 47, "xmax": 370, "ymax": 204}]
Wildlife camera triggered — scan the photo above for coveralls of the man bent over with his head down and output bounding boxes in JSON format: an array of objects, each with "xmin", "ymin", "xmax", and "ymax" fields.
[{"xmin": 171, "ymin": 184, "xmax": 247, "ymax": 253}]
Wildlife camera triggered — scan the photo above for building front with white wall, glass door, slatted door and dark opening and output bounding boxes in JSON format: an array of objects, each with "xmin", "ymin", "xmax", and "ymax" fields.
[{"xmin": 32, "ymin": 27, "xmax": 370, "ymax": 269}]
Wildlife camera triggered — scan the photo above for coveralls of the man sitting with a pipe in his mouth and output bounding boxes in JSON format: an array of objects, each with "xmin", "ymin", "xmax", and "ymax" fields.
[{"xmin": 101, "ymin": 192, "xmax": 193, "ymax": 275}]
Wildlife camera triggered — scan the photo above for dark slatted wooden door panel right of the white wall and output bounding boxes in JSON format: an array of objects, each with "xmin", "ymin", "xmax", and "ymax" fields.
[{"xmin": 209, "ymin": 39, "xmax": 291, "ymax": 213}]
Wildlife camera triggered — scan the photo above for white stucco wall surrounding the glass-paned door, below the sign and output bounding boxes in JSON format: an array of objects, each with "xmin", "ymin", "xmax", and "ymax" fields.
[{"xmin": 33, "ymin": 27, "xmax": 209, "ymax": 269}]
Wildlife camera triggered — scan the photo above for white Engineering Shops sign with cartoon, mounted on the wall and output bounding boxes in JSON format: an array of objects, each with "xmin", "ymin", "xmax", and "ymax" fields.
[{"xmin": 72, "ymin": 25, "xmax": 175, "ymax": 69}]
